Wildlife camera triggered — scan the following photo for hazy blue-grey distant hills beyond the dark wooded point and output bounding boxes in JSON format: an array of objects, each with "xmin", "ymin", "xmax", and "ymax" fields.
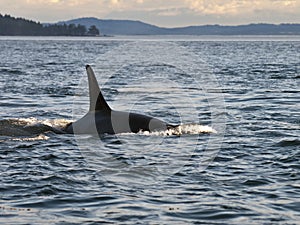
[{"xmin": 58, "ymin": 17, "xmax": 300, "ymax": 35}]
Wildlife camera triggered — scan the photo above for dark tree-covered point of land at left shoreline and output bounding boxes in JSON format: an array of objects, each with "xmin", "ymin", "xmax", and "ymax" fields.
[{"xmin": 0, "ymin": 14, "xmax": 100, "ymax": 36}]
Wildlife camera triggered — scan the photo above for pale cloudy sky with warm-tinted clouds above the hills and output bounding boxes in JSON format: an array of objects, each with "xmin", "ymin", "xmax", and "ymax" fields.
[{"xmin": 0, "ymin": 0, "xmax": 300, "ymax": 27}]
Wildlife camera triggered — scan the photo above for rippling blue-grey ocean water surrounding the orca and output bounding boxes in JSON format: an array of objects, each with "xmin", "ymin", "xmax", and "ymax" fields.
[{"xmin": 0, "ymin": 36, "xmax": 300, "ymax": 224}]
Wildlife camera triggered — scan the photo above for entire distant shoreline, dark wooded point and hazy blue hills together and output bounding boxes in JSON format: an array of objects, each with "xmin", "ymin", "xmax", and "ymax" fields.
[{"xmin": 0, "ymin": 14, "xmax": 300, "ymax": 37}]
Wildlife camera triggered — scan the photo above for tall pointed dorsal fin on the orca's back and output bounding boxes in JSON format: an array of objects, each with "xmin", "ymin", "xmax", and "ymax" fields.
[{"xmin": 85, "ymin": 65, "xmax": 111, "ymax": 111}]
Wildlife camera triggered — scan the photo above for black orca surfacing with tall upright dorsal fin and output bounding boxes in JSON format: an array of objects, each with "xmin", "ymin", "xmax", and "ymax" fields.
[{"xmin": 64, "ymin": 65, "xmax": 177, "ymax": 134}]
